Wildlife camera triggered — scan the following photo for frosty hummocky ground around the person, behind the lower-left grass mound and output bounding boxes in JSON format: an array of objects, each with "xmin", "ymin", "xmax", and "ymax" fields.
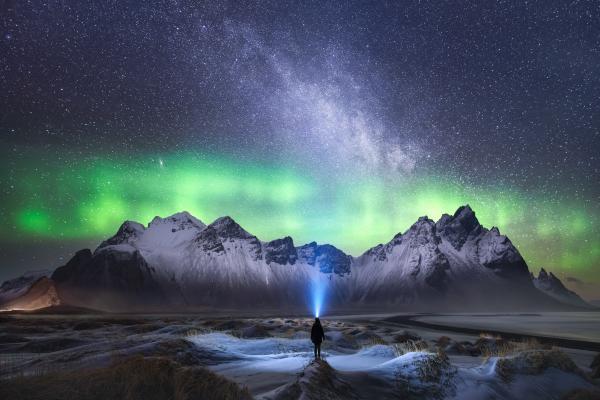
[{"xmin": 0, "ymin": 315, "xmax": 598, "ymax": 399}]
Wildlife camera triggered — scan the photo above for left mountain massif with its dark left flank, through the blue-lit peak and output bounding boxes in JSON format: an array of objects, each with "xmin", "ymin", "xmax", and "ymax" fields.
[{"xmin": 52, "ymin": 212, "xmax": 350, "ymax": 308}]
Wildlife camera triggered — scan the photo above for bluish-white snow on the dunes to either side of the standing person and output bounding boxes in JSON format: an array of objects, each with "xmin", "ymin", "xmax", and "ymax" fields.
[{"xmin": 188, "ymin": 333, "xmax": 596, "ymax": 400}]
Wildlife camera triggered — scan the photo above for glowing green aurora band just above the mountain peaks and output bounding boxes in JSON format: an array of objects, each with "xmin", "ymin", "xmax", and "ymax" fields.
[{"xmin": 0, "ymin": 149, "xmax": 600, "ymax": 290}]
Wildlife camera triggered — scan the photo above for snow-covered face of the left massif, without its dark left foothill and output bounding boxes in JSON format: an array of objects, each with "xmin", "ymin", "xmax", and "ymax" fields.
[{"xmin": 82, "ymin": 212, "xmax": 344, "ymax": 306}]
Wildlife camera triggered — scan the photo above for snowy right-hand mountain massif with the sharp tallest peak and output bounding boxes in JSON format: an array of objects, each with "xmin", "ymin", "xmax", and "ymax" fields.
[{"xmin": 342, "ymin": 206, "xmax": 545, "ymax": 307}]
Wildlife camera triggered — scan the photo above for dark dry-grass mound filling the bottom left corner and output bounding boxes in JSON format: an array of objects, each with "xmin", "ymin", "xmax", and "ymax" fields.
[{"xmin": 0, "ymin": 357, "xmax": 251, "ymax": 400}]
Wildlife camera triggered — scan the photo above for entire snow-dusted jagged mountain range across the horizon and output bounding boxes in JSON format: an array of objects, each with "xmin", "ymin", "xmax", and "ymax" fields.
[{"xmin": 0, "ymin": 205, "xmax": 591, "ymax": 312}]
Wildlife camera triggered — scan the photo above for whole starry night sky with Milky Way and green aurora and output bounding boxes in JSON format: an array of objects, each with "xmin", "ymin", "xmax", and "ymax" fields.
[{"xmin": 0, "ymin": 0, "xmax": 600, "ymax": 299}]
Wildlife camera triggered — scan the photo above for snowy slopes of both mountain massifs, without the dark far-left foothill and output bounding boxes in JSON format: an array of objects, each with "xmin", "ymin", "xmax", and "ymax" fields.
[{"xmin": 91, "ymin": 206, "xmax": 564, "ymax": 307}]
